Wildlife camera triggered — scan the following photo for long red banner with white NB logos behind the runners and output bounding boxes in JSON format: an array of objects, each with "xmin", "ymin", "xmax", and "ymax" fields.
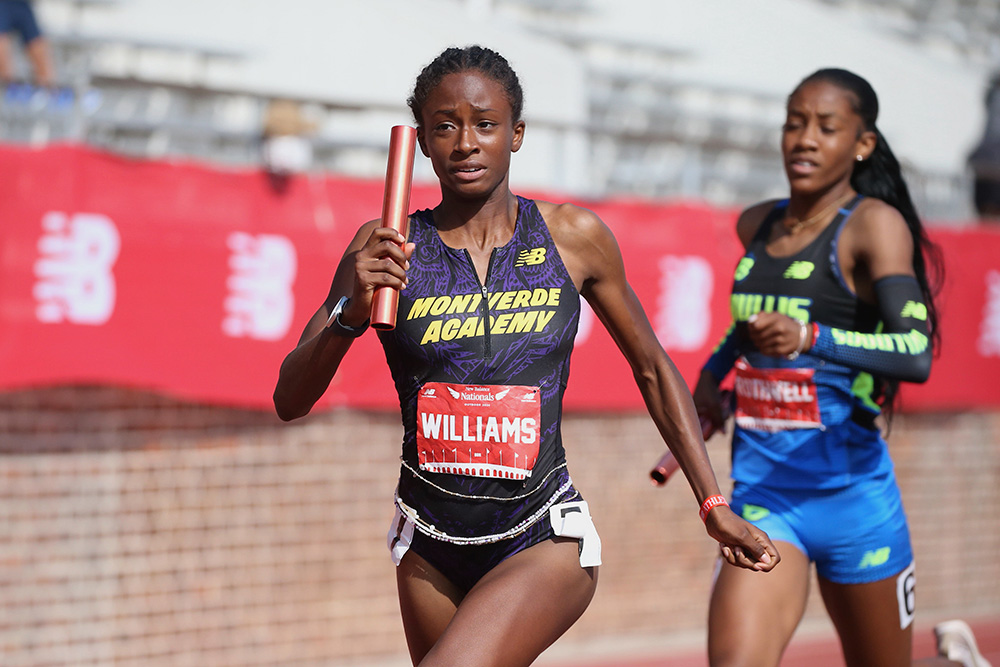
[{"xmin": 0, "ymin": 146, "xmax": 1000, "ymax": 410}]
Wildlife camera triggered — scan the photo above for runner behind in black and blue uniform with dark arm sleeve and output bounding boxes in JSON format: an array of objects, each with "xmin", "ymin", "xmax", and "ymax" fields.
[{"xmin": 694, "ymin": 70, "xmax": 988, "ymax": 667}]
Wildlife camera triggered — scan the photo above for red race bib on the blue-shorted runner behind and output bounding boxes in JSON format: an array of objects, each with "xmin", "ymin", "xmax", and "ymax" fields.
[{"xmin": 734, "ymin": 358, "xmax": 823, "ymax": 433}]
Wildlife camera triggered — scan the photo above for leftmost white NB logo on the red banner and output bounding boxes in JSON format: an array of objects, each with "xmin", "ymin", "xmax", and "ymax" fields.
[{"xmin": 33, "ymin": 211, "xmax": 121, "ymax": 326}]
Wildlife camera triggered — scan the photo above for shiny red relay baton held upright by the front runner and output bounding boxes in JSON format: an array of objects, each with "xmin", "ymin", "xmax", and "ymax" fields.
[{"xmin": 371, "ymin": 125, "xmax": 417, "ymax": 329}]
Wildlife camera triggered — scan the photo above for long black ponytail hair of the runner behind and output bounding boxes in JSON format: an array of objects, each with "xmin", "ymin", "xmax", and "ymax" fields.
[{"xmin": 789, "ymin": 68, "xmax": 944, "ymax": 410}]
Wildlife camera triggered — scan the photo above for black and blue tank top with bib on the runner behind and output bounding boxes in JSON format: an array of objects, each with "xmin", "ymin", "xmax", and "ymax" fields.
[{"xmin": 730, "ymin": 195, "xmax": 892, "ymax": 488}]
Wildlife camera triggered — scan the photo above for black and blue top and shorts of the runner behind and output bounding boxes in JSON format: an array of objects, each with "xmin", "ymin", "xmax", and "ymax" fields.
[{"xmin": 732, "ymin": 196, "xmax": 913, "ymax": 584}]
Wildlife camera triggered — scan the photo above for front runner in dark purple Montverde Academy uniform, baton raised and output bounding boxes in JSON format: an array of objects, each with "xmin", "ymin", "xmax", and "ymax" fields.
[{"xmin": 274, "ymin": 47, "xmax": 779, "ymax": 667}]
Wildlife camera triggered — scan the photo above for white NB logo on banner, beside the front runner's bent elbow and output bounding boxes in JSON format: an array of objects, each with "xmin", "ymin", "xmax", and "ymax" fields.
[{"xmin": 228, "ymin": 232, "xmax": 298, "ymax": 340}]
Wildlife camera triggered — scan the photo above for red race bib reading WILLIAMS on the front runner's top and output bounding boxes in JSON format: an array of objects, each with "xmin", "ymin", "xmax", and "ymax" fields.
[{"xmin": 417, "ymin": 382, "xmax": 542, "ymax": 479}]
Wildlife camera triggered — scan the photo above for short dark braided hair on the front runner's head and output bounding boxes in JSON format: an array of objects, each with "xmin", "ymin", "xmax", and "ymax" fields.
[{"xmin": 406, "ymin": 46, "xmax": 524, "ymax": 126}]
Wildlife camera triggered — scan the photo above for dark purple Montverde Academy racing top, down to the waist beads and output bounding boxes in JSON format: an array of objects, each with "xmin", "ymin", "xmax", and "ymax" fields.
[{"xmin": 379, "ymin": 197, "xmax": 580, "ymax": 539}]
